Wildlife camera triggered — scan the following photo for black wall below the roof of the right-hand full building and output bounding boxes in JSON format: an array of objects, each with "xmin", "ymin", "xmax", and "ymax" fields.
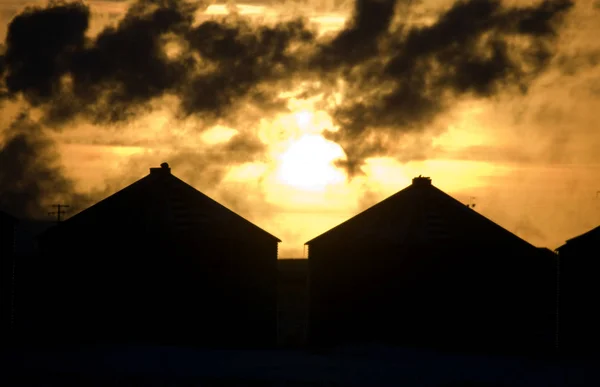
[{"xmin": 309, "ymin": 238, "xmax": 556, "ymax": 358}]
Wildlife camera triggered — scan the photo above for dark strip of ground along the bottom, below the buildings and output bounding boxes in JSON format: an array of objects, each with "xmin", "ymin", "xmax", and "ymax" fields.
[{"xmin": 0, "ymin": 347, "xmax": 600, "ymax": 387}]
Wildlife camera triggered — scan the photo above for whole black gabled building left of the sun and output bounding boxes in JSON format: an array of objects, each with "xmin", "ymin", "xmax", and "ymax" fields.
[{"xmin": 36, "ymin": 163, "xmax": 280, "ymax": 348}]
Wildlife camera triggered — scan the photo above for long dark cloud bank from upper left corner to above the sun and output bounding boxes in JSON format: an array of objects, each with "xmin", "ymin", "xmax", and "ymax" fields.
[{"xmin": 4, "ymin": 0, "xmax": 313, "ymax": 124}]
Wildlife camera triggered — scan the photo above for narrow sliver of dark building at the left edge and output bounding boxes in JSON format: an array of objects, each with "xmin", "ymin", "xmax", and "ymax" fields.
[{"xmin": 0, "ymin": 211, "xmax": 18, "ymax": 344}]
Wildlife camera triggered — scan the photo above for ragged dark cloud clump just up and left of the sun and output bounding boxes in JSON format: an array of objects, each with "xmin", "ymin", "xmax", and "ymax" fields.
[{"xmin": 180, "ymin": 15, "xmax": 314, "ymax": 118}]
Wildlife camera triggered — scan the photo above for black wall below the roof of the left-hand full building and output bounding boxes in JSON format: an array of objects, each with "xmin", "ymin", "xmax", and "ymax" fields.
[{"xmin": 39, "ymin": 222, "xmax": 277, "ymax": 347}]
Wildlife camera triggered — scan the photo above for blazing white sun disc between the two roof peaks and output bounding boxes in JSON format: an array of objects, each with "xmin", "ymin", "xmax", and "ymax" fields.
[{"xmin": 277, "ymin": 135, "xmax": 345, "ymax": 191}]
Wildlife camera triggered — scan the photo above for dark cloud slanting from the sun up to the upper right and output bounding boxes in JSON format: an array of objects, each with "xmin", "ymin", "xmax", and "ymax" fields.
[{"xmin": 330, "ymin": 0, "xmax": 573, "ymax": 176}]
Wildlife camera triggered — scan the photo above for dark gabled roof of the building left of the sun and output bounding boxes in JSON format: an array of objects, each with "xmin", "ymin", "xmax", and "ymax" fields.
[{"xmin": 41, "ymin": 163, "xmax": 281, "ymax": 242}]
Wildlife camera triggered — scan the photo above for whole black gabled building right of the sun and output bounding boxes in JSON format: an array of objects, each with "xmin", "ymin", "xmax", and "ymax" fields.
[{"xmin": 307, "ymin": 177, "xmax": 556, "ymax": 353}]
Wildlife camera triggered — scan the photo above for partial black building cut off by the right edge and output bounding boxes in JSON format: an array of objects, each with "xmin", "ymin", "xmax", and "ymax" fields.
[{"xmin": 556, "ymin": 227, "xmax": 600, "ymax": 355}]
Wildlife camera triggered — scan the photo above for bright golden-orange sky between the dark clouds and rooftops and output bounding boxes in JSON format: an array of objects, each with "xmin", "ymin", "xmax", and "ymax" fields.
[{"xmin": 0, "ymin": 0, "xmax": 600, "ymax": 257}]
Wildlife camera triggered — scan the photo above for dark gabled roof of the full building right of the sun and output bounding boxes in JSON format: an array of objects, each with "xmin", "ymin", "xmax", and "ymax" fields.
[{"xmin": 306, "ymin": 177, "xmax": 535, "ymax": 252}]
